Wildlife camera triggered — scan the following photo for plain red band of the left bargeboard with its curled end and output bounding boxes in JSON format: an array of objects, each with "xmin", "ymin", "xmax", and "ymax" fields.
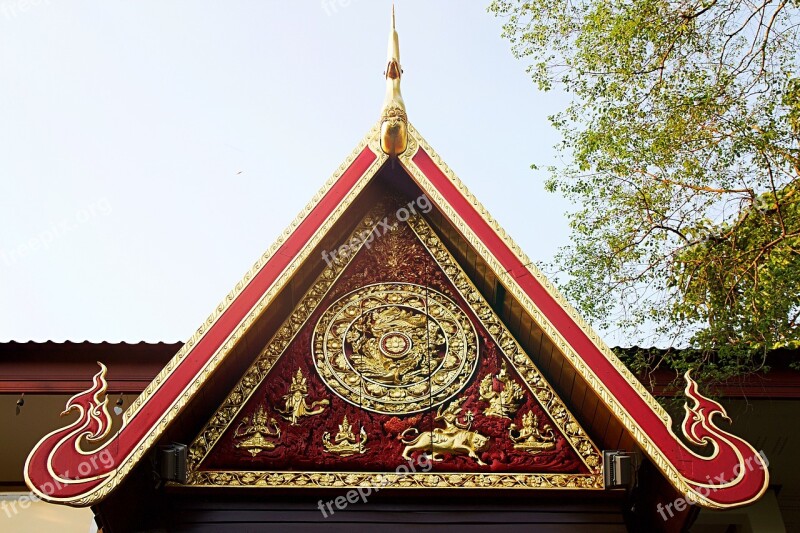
[{"xmin": 26, "ymin": 147, "xmax": 377, "ymax": 500}]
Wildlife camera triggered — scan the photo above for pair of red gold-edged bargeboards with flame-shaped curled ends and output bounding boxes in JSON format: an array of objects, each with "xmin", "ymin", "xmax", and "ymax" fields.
[{"xmin": 25, "ymin": 120, "xmax": 768, "ymax": 507}]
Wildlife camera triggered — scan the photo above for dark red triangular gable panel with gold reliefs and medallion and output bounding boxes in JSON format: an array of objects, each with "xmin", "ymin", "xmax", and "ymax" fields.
[{"xmin": 189, "ymin": 200, "xmax": 603, "ymax": 489}]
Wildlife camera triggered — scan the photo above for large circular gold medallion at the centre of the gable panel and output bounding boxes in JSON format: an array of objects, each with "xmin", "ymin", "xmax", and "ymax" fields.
[{"xmin": 312, "ymin": 283, "xmax": 478, "ymax": 414}]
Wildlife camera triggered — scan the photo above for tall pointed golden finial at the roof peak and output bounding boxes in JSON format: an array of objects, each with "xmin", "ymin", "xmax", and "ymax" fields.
[{"xmin": 381, "ymin": 5, "xmax": 408, "ymax": 157}]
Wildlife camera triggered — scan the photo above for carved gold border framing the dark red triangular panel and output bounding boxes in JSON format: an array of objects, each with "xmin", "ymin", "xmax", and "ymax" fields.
[{"xmin": 188, "ymin": 206, "xmax": 603, "ymax": 489}]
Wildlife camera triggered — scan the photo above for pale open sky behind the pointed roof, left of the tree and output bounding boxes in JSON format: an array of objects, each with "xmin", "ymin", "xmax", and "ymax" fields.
[{"xmin": 0, "ymin": 0, "xmax": 569, "ymax": 342}]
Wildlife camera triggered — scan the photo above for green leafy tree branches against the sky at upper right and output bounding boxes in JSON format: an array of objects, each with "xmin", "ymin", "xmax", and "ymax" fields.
[{"xmin": 489, "ymin": 0, "xmax": 800, "ymax": 378}]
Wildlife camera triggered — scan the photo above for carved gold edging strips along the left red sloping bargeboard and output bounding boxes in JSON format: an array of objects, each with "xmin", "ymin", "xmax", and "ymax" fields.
[{"xmin": 53, "ymin": 123, "xmax": 388, "ymax": 507}]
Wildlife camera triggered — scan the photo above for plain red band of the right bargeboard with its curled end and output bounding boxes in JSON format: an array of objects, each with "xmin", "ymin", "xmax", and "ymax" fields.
[{"xmin": 413, "ymin": 147, "xmax": 766, "ymax": 505}]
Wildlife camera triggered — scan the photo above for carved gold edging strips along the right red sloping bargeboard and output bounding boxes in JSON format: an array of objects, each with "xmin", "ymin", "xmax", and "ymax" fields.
[{"xmin": 399, "ymin": 123, "xmax": 769, "ymax": 508}]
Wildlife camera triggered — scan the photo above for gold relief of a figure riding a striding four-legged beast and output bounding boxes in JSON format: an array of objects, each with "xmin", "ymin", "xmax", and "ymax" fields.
[{"xmin": 397, "ymin": 398, "xmax": 489, "ymax": 466}]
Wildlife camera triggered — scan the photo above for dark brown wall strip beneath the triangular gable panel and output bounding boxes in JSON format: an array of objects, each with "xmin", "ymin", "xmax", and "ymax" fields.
[{"xmin": 97, "ymin": 489, "xmax": 629, "ymax": 533}]
